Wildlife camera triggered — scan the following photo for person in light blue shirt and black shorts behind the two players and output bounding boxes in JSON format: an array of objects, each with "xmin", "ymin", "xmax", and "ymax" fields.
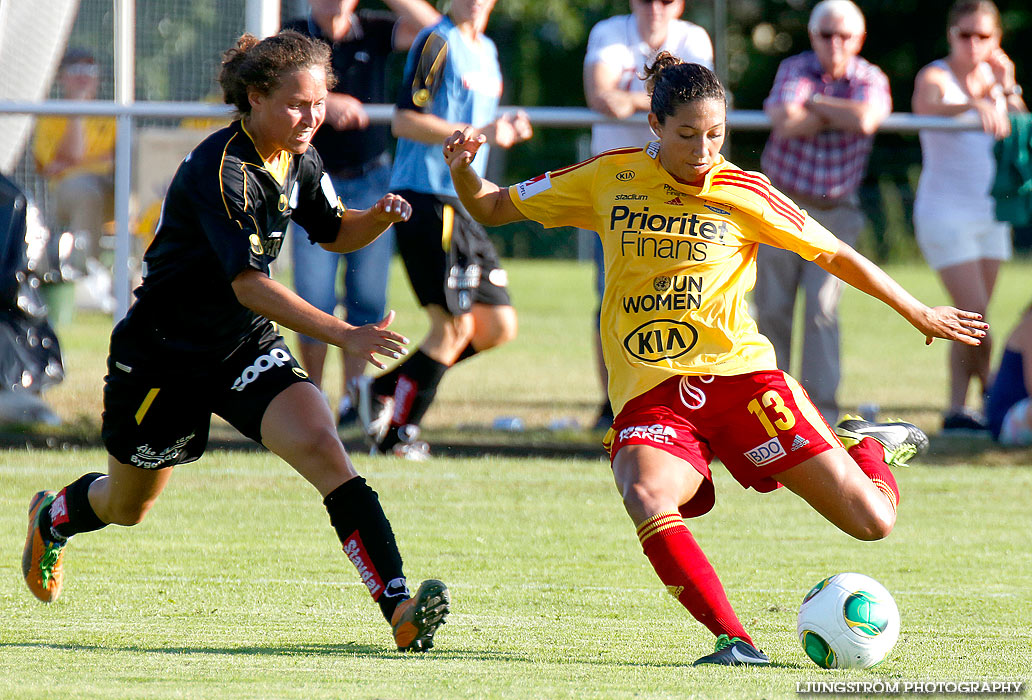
[{"xmin": 358, "ymin": 0, "xmax": 533, "ymax": 459}]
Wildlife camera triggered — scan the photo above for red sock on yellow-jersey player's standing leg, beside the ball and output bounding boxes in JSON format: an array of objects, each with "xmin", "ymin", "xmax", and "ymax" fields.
[{"xmin": 638, "ymin": 512, "xmax": 752, "ymax": 644}]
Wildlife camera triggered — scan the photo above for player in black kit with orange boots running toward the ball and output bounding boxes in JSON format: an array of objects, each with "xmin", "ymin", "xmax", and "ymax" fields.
[{"xmin": 22, "ymin": 32, "xmax": 449, "ymax": 650}]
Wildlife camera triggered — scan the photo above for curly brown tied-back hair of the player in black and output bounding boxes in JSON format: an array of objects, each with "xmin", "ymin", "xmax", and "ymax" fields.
[{"xmin": 219, "ymin": 29, "xmax": 336, "ymax": 115}]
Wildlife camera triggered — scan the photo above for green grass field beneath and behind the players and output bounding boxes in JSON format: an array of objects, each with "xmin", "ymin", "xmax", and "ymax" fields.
[{"xmin": 0, "ymin": 262, "xmax": 1032, "ymax": 698}]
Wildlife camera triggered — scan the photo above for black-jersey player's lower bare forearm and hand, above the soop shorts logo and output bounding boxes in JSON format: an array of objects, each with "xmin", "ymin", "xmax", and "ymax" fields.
[{"xmin": 232, "ymin": 268, "xmax": 409, "ymax": 370}]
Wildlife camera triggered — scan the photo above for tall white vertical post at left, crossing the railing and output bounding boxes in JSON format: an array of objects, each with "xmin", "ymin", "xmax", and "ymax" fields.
[{"xmin": 111, "ymin": 0, "xmax": 136, "ymax": 322}]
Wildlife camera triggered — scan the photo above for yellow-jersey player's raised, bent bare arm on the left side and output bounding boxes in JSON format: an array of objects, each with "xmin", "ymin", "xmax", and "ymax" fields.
[{"xmin": 444, "ymin": 127, "xmax": 526, "ymax": 226}]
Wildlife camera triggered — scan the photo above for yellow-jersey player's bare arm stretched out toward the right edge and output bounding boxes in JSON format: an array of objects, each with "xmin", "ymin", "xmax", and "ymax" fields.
[{"xmin": 814, "ymin": 242, "xmax": 989, "ymax": 345}]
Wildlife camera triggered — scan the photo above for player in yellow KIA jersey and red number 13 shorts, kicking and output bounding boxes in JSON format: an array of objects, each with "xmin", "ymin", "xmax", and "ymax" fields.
[{"xmin": 444, "ymin": 53, "xmax": 989, "ymax": 665}]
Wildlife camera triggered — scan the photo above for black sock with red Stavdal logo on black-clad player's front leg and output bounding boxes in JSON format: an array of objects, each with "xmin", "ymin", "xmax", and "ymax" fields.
[{"xmin": 323, "ymin": 476, "xmax": 412, "ymax": 623}]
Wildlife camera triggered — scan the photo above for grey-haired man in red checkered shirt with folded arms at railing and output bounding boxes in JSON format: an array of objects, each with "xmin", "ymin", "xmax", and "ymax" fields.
[{"xmin": 753, "ymin": 0, "xmax": 892, "ymax": 424}]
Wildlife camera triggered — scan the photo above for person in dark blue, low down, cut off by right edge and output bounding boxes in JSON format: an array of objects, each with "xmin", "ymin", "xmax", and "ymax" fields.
[{"xmin": 986, "ymin": 306, "xmax": 1032, "ymax": 446}]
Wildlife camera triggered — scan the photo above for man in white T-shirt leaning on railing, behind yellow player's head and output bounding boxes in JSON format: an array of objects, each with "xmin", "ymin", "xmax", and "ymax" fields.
[{"xmin": 584, "ymin": 0, "xmax": 713, "ymax": 429}]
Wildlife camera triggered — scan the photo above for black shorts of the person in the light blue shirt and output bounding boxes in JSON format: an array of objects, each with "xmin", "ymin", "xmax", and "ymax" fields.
[{"xmin": 394, "ymin": 190, "xmax": 512, "ymax": 316}]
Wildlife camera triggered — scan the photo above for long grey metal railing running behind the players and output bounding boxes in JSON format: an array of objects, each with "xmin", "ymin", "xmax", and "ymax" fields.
[{"xmin": 0, "ymin": 98, "xmax": 981, "ymax": 320}]
